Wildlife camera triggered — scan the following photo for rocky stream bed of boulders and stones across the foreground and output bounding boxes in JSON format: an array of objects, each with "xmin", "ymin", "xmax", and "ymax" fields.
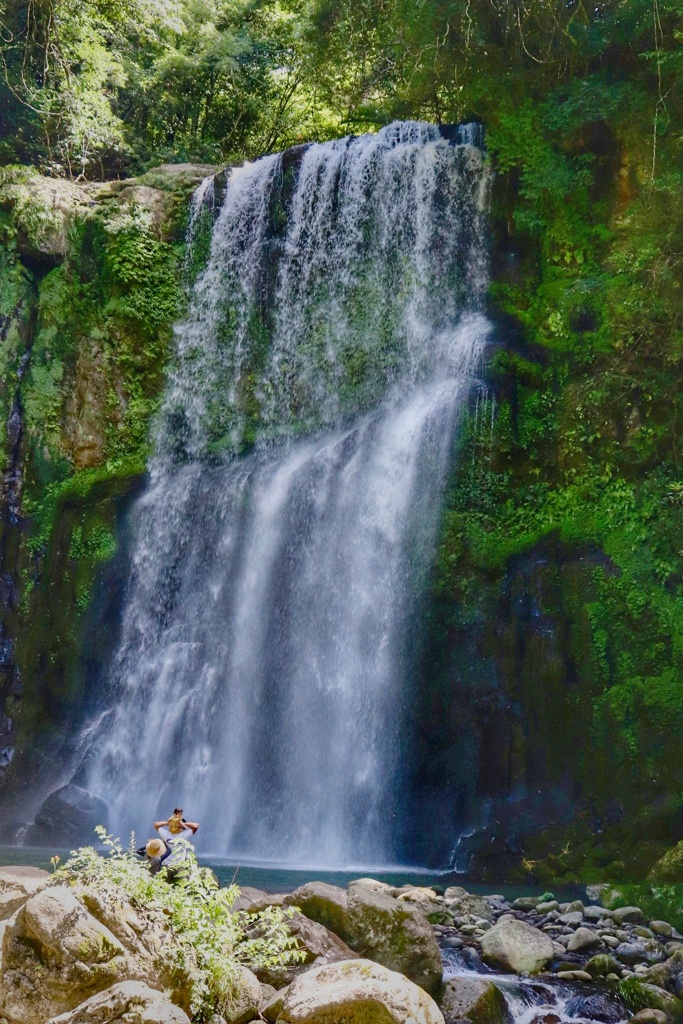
[{"xmin": 0, "ymin": 866, "xmax": 683, "ymax": 1024}]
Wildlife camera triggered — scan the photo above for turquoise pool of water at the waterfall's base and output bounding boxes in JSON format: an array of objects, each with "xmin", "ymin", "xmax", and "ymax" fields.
[{"xmin": 0, "ymin": 847, "xmax": 586, "ymax": 899}]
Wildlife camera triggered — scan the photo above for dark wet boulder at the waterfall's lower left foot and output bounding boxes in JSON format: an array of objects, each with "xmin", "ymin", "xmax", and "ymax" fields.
[{"xmin": 26, "ymin": 782, "xmax": 109, "ymax": 847}]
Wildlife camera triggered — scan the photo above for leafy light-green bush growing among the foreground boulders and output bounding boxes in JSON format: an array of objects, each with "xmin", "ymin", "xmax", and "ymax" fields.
[{"xmin": 54, "ymin": 827, "xmax": 303, "ymax": 1021}]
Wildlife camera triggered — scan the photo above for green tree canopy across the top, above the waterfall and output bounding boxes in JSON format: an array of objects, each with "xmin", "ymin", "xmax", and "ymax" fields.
[{"xmin": 0, "ymin": 0, "xmax": 683, "ymax": 177}]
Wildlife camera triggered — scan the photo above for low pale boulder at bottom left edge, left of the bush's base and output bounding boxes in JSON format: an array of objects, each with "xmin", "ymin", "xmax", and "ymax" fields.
[{"xmin": 48, "ymin": 981, "xmax": 189, "ymax": 1024}]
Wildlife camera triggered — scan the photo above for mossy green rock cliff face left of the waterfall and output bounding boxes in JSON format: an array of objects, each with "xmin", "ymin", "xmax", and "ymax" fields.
[{"xmin": 0, "ymin": 164, "xmax": 214, "ymax": 819}]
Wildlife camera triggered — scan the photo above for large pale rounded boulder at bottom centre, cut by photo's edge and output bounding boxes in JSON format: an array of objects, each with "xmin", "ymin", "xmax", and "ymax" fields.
[{"xmin": 276, "ymin": 958, "xmax": 444, "ymax": 1024}]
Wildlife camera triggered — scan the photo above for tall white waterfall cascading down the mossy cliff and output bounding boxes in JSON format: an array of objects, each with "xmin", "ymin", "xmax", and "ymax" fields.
[{"xmin": 88, "ymin": 122, "xmax": 487, "ymax": 867}]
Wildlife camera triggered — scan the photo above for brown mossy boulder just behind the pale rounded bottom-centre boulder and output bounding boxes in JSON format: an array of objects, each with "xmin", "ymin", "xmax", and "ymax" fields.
[{"xmin": 345, "ymin": 884, "xmax": 444, "ymax": 992}]
